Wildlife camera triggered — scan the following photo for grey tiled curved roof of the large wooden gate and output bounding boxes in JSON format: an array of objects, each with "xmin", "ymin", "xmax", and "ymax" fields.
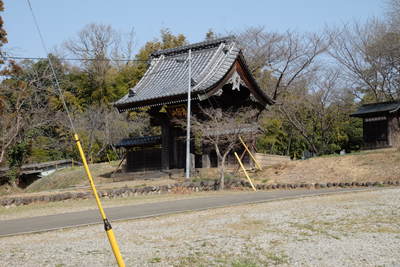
[{"xmin": 115, "ymin": 37, "xmax": 274, "ymax": 111}]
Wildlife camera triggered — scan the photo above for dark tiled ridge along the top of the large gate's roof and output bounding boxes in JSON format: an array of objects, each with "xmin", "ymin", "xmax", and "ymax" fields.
[{"xmin": 151, "ymin": 35, "xmax": 236, "ymax": 58}]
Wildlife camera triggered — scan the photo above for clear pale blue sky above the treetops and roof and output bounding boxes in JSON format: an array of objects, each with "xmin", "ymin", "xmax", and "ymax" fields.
[{"xmin": 3, "ymin": 0, "xmax": 385, "ymax": 56}]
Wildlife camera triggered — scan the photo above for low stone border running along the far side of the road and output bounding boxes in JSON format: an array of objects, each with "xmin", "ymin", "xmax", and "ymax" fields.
[{"xmin": 0, "ymin": 179, "xmax": 400, "ymax": 207}]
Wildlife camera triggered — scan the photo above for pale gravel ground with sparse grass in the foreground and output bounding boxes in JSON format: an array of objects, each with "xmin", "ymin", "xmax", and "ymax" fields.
[{"xmin": 0, "ymin": 189, "xmax": 400, "ymax": 267}]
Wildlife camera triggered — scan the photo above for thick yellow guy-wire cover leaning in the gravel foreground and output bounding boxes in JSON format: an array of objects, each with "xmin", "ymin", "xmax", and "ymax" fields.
[{"xmin": 74, "ymin": 134, "xmax": 125, "ymax": 267}]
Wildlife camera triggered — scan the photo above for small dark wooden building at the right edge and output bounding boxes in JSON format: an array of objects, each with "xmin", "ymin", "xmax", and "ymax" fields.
[{"xmin": 350, "ymin": 101, "xmax": 400, "ymax": 149}]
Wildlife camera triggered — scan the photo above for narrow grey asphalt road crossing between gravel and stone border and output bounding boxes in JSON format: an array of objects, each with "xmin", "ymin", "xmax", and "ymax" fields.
[{"xmin": 0, "ymin": 188, "xmax": 372, "ymax": 237}]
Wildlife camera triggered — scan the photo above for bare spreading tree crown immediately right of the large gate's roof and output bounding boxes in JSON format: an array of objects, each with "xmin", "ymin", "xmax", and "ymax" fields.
[{"xmin": 239, "ymin": 27, "xmax": 329, "ymax": 100}]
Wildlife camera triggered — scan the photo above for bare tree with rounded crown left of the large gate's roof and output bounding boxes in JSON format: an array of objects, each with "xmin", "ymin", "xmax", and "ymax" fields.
[{"xmin": 64, "ymin": 24, "xmax": 134, "ymax": 104}]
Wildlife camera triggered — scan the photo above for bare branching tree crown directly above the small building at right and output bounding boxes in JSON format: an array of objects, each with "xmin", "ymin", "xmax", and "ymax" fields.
[{"xmin": 328, "ymin": 19, "xmax": 400, "ymax": 101}]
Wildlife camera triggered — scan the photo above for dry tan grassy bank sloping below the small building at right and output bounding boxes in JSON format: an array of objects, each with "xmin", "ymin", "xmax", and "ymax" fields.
[{"xmin": 252, "ymin": 149, "xmax": 400, "ymax": 183}]
